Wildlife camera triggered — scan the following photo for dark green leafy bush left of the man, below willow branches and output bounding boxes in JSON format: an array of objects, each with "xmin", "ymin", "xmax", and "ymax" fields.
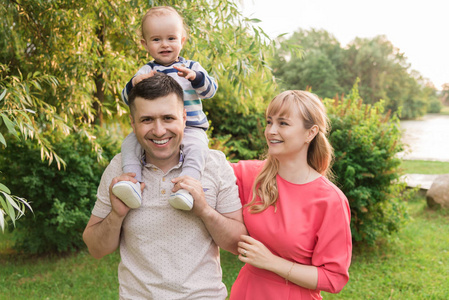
[{"xmin": 0, "ymin": 134, "xmax": 116, "ymax": 253}]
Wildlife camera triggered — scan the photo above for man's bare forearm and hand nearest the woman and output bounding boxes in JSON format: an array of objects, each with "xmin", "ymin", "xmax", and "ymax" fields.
[{"xmin": 173, "ymin": 176, "xmax": 248, "ymax": 255}]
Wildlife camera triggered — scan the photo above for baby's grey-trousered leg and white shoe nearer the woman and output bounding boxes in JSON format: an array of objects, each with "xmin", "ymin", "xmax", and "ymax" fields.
[{"xmin": 168, "ymin": 127, "xmax": 209, "ymax": 210}]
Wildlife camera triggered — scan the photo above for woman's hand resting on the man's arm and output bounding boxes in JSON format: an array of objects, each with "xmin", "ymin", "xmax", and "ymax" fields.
[{"xmin": 238, "ymin": 235, "xmax": 276, "ymax": 269}]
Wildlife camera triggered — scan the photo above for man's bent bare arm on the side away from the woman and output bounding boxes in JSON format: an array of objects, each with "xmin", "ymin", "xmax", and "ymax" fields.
[{"xmin": 83, "ymin": 173, "xmax": 141, "ymax": 259}]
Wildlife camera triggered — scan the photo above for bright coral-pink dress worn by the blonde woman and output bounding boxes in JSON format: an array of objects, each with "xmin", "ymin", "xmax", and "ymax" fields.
[{"xmin": 230, "ymin": 161, "xmax": 352, "ymax": 300}]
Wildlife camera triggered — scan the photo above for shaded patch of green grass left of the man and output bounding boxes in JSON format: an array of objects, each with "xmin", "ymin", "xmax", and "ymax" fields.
[{"xmin": 0, "ymin": 233, "xmax": 119, "ymax": 300}]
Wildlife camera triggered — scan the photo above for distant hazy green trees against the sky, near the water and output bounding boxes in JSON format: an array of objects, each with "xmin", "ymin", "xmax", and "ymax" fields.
[{"xmin": 272, "ymin": 29, "xmax": 438, "ymax": 118}]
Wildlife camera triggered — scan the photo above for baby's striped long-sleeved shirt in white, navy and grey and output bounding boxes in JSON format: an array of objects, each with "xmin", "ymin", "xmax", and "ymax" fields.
[{"xmin": 122, "ymin": 57, "xmax": 218, "ymax": 130}]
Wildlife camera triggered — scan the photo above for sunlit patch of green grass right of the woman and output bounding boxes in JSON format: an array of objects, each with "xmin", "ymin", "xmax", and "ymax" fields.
[{"xmin": 323, "ymin": 198, "xmax": 449, "ymax": 300}]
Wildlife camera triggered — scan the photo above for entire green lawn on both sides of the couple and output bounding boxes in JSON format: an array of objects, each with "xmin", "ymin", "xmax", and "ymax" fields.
[{"xmin": 0, "ymin": 198, "xmax": 449, "ymax": 300}]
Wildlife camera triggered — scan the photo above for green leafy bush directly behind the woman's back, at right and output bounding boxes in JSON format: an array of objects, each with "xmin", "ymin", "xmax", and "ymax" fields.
[{"xmin": 325, "ymin": 87, "xmax": 412, "ymax": 244}]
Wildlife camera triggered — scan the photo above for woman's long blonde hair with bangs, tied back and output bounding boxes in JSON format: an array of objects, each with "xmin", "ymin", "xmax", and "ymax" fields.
[{"xmin": 247, "ymin": 90, "xmax": 333, "ymax": 213}]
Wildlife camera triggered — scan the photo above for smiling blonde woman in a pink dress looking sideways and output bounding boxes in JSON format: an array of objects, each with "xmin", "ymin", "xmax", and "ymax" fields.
[{"xmin": 230, "ymin": 91, "xmax": 352, "ymax": 300}]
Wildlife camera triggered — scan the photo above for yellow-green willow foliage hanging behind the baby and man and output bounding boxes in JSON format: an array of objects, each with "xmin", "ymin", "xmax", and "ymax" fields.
[{"xmin": 0, "ymin": 0, "xmax": 274, "ymax": 249}]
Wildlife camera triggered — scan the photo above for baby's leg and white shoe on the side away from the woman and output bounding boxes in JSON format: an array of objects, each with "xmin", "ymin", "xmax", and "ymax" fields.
[{"xmin": 112, "ymin": 132, "xmax": 142, "ymax": 208}]
